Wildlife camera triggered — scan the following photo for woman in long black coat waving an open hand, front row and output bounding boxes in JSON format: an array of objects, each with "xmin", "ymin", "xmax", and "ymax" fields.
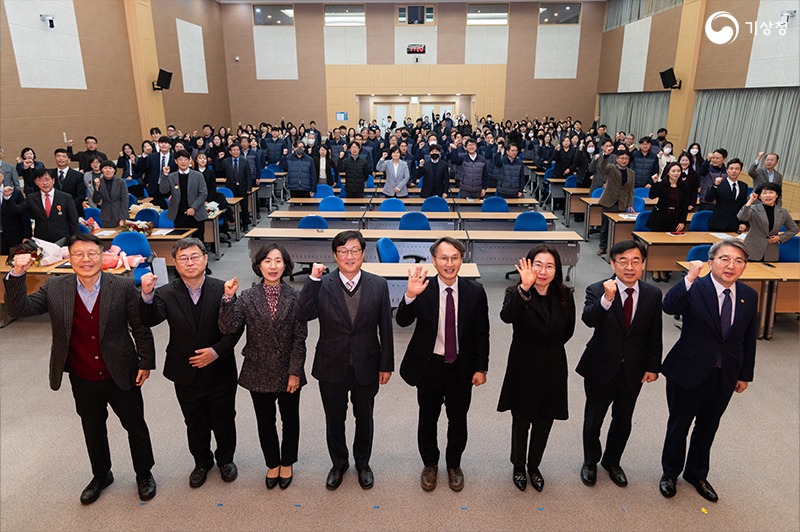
[{"xmin": 497, "ymin": 244, "xmax": 575, "ymax": 491}]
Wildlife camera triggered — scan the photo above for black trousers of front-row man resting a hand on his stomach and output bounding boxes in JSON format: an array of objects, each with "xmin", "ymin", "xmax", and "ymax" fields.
[{"xmin": 175, "ymin": 378, "xmax": 238, "ymax": 465}]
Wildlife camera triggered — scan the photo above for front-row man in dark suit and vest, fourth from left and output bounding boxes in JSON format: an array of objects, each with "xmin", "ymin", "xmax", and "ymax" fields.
[{"xmin": 297, "ymin": 231, "xmax": 394, "ymax": 490}]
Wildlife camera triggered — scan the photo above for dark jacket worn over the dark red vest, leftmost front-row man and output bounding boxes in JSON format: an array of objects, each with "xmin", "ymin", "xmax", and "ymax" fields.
[{"xmin": 5, "ymin": 274, "xmax": 156, "ymax": 390}]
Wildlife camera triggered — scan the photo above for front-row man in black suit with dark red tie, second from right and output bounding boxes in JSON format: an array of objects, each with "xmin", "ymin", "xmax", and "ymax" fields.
[{"xmin": 576, "ymin": 240, "xmax": 662, "ymax": 486}]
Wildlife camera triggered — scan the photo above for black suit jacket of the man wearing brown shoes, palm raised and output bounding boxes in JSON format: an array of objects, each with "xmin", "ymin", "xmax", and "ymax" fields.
[{"xmin": 396, "ymin": 276, "xmax": 489, "ymax": 386}]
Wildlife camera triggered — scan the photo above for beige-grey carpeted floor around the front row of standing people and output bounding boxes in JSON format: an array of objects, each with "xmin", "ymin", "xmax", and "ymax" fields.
[{"xmin": 0, "ymin": 203, "xmax": 800, "ymax": 531}]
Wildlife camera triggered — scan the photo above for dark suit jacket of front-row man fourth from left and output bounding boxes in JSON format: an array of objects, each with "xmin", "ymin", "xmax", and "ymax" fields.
[{"xmin": 297, "ymin": 269, "xmax": 394, "ymax": 386}]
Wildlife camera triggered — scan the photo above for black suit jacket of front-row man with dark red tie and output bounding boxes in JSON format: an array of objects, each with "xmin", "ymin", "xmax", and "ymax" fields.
[{"xmin": 575, "ymin": 281, "xmax": 662, "ymax": 387}]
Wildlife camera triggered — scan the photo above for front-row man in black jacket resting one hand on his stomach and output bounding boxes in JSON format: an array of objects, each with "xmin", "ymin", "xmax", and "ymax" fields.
[{"xmin": 139, "ymin": 238, "xmax": 242, "ymax": 488}]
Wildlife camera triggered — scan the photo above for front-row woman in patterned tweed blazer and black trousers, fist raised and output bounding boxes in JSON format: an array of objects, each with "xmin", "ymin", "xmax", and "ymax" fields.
[{"xmin": 219, "ymin": 243, "xmax": 308, "ymax": 489}]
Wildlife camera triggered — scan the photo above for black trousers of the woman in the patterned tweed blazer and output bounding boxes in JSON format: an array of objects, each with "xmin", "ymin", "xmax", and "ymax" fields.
[{"xmin": 250, "ymin": 389, "xmax": 300, "ymax": 469}]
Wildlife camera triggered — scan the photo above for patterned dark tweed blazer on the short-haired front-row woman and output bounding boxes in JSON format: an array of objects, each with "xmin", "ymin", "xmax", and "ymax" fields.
[{"xmin": 219, "ymin": 281, "xmax": 308, "ymax": 393}]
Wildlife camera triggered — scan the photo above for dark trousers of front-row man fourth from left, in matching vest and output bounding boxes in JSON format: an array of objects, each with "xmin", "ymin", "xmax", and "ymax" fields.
[{"xmin": 319, "ymin": 366, "xmax": 379, "ymax": 470}]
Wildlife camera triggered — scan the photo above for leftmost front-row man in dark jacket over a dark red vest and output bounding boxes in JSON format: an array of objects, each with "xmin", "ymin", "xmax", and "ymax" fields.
[{"xmin": 5, "ymin": 235, "xmax": 156, "ymax": 504}]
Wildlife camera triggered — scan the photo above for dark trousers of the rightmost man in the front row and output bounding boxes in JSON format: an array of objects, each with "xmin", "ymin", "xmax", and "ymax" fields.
[{"xmin": 661, "ymin": 368, "xmax": 733, "ymax": 480}]
